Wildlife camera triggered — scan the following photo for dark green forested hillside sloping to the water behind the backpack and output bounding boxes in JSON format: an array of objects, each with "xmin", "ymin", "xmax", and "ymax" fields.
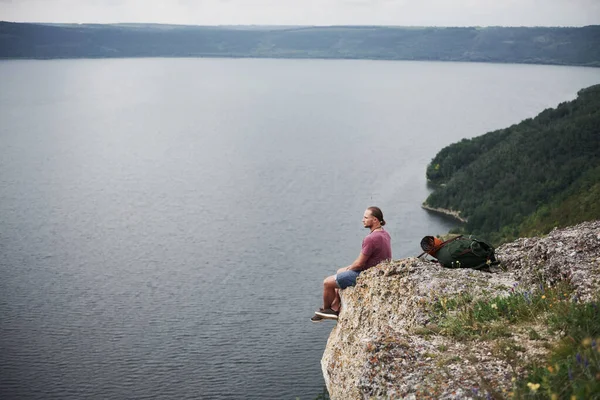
[{"xmin": 425, "ymin": 85, "xmax": 600, "ymax": 243}]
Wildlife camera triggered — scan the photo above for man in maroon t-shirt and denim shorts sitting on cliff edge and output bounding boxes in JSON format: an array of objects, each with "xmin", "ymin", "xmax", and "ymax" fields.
[{"xmin": 310, "ymin": 207, "xmax": 392, "ymax": 322}]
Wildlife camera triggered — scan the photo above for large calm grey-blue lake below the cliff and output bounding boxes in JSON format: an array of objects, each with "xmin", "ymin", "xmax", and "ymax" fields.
[{"xmin": 0, "ymin": 59, "xmax": 600, "ymax": 400}]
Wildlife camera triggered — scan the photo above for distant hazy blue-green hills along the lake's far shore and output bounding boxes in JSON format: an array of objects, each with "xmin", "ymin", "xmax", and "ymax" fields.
[{"xmin": 0, "ymin": 22, "xmax": 600, "ymax": 67}]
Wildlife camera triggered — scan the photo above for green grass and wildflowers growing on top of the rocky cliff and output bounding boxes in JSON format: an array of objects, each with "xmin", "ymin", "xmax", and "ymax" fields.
[{"xmin": 431, "ymin": 283, "xmax": 600, "ymax": 400}]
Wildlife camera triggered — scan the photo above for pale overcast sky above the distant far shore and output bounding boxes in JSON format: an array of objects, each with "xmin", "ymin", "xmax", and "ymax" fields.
[{"xmin": 0, "ymin": 0, "xmax": 600, "ymax": 26}]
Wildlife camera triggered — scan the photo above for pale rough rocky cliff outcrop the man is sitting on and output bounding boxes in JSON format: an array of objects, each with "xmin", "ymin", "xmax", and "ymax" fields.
[{"xmin": 321, "ymin": 221, "xmax": 600, "ymax": 399}]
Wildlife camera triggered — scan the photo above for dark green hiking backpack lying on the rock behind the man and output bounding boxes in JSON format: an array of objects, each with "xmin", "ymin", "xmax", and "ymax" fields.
[{"xmin": 421, "ymin": 235, "xmax": 499, "ymax": 269}]
